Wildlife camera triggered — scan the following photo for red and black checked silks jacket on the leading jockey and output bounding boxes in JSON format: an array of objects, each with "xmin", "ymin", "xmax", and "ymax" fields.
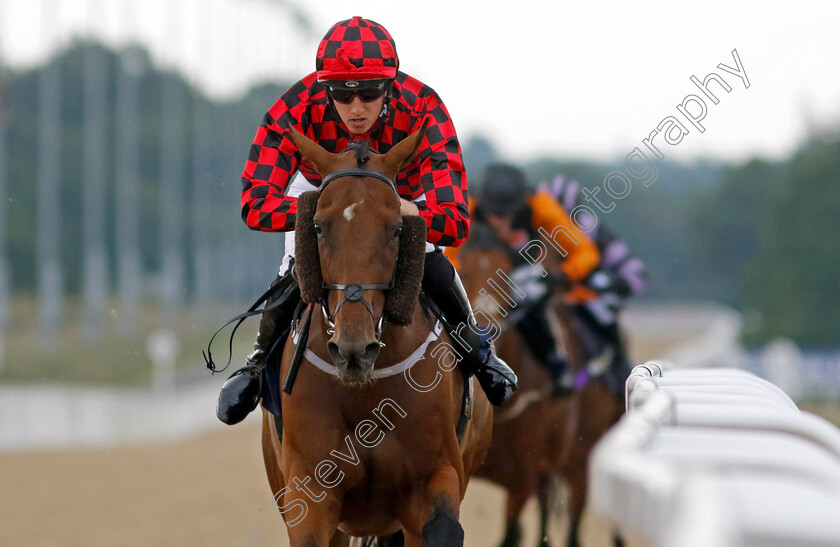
[{"xmin": 242, "ymin": 72, "xmax": 469, "ymax": 246}]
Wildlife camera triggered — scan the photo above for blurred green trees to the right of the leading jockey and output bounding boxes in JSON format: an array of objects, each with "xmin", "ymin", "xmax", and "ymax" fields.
[{"xmin": 465, "ymin": 127, "xmax": 840, "ymax": 348}]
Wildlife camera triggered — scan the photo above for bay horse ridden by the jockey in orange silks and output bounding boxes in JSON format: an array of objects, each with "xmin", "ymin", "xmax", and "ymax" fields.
[{"xmin": 458, "ymin": 223, "xmax": 623, "ymax": 547}]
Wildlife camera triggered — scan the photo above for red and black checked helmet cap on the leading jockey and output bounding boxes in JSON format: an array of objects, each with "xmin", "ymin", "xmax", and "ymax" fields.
[{"xmin": 315, "ymin": 17, "xmax": 400, "ymax": 80}]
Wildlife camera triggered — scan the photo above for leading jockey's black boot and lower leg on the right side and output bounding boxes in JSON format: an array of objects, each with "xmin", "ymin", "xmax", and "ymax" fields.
[{"xmin": 430, "ymin": 272, "xmax": 518, "ymax": 406}]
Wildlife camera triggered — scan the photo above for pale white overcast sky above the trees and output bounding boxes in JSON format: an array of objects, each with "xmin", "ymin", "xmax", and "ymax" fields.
[{"xmin": 0, "ymin": 0, "xmax": 840, "ymax": 161}]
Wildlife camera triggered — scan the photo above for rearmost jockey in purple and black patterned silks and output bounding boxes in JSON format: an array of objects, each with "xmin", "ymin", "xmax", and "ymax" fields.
[{"xmin": 539, "ymin": 175, "xmax": 648, "ymax": 397}]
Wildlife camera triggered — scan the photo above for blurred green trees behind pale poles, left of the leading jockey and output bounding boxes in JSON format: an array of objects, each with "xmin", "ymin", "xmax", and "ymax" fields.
[{"xmin": 0, "ymin": 38, "xmax": 286, "ymax": 304}]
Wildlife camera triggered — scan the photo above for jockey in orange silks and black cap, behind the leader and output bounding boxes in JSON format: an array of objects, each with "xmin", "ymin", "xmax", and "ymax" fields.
[{"xmin": 446, "ymin": 164, "xmax": 601, "ymax": 397}]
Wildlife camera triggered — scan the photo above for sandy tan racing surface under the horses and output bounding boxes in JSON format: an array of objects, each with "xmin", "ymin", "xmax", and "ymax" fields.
[{"xmin": 0, "ymin": 418, "xmax": 616, "ymax": 547}]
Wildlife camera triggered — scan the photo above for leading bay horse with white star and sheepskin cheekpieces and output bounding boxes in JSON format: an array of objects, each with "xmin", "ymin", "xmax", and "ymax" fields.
[{"xmin": 262, "ymin": 124, "xmax": 492, "ymax": 547}]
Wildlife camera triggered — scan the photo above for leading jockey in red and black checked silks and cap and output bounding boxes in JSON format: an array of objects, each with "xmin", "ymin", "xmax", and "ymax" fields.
[{"xmin": 216, "ymin": 17, "xmax": 517, "ymax": 424}]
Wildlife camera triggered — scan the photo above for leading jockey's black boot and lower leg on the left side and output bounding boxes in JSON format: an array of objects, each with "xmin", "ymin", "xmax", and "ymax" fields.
[{"xmin": 216, "ymin": 273, "xmax": 300, "ymax": 425}]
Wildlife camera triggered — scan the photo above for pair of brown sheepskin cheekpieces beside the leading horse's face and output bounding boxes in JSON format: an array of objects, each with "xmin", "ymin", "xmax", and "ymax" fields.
[{"xmin": 295, "ymin": 191, "xmax": 426, "ymax": 325}]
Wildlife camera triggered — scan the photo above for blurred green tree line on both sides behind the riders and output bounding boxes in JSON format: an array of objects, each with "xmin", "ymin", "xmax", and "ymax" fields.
[{"xmin": 0, "ymin": 43, "xmax": 840, "ymax": 347}]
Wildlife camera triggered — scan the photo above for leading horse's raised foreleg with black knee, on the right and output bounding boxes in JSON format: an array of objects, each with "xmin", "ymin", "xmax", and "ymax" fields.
[{"xmin": 403, "ymin": 467, "xmax": 464, "ymax": 547}]
